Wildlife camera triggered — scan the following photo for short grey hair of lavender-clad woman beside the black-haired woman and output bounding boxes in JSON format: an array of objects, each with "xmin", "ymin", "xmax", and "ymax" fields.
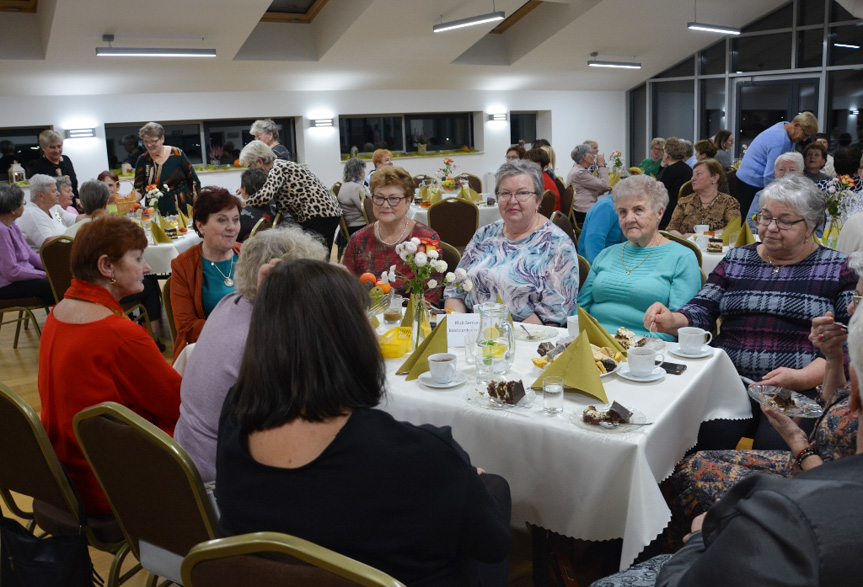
[{"xmin": 236, "ymin": 226, "xmax": 327, "ymax": 302}]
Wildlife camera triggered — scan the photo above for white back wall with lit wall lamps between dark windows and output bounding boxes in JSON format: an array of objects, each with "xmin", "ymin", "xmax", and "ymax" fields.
[{"xmin": 0, "ymin": 90, "xmax": 626, "ymax": 187}]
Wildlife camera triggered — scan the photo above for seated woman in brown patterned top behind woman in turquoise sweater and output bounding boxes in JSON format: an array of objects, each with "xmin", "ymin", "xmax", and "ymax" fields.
[{"xmin": 668, "ymin": 159, "xmax": 740, "ymax": 236}]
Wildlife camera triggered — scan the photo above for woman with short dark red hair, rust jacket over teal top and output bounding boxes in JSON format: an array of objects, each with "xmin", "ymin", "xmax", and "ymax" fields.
[{"xmin": 171, "ymin": 186, "xmax": 240, "ymax": 359}]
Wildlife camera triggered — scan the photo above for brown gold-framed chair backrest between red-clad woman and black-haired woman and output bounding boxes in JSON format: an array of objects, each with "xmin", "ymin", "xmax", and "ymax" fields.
[{"xmin": 73, "ymin": 402, "xmax": 218, "ymax": 570}]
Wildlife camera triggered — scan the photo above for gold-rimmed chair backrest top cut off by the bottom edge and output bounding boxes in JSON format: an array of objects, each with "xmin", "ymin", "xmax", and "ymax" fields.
[{"xmin": 182, "ymin": 532, "xmax": 403, "ymax": 587}]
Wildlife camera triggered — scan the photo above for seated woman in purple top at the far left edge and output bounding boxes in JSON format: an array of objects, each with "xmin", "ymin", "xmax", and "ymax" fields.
[{"xmin": 0, "ymin": 185, "xmax": 54, "ymax": 304}]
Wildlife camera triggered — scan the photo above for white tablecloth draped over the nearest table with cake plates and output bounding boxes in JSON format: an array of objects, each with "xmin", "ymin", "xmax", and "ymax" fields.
[{"xmin": 381, "ymin": 329, "xmax": 751, "ymax": 569}]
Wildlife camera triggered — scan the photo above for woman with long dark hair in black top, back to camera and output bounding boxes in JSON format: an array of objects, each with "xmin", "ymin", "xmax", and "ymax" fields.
[{"xmin": 218, "ymin": 260, "xmax": 511, "ymax": 585}]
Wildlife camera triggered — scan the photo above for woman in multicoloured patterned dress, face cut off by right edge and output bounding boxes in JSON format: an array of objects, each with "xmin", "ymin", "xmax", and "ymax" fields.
[{"xmin": 667, "ymin": 252, "xmax": 863, "ymax": 546}]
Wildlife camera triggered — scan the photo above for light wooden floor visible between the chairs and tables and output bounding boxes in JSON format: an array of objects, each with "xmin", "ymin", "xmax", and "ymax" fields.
[{"xmin": 0, "ymin": 311, "xmax": 533, "ymax": 587}]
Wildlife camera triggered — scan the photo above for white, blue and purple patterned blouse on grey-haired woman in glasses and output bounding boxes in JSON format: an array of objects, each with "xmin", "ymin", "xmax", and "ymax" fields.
[{"xmin": 444, "ymin": 220, "xmax": 578, "ymax": 324}]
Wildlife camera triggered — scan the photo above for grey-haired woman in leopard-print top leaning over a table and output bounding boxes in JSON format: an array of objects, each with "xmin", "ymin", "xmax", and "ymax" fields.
[{"xmin": 240, "ymin": 141, "xmax": 342, "ymax": 251}]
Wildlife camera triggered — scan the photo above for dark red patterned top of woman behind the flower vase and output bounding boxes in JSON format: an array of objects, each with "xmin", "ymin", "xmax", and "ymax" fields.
[{"xmin": 342, "ymin": 222, "xmax": 442, "ymax": 304}]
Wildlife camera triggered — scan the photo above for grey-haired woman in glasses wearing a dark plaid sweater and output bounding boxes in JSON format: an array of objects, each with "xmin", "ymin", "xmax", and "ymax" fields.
[{"xmin": 644, "ymin": 175, "xmax": 857, "ymax": 449}]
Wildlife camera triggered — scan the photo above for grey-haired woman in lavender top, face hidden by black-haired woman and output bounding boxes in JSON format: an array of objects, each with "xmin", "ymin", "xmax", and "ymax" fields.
[{"xmin": 174, "ymin": 227, "xmax": 325, "ymax": 483}]
